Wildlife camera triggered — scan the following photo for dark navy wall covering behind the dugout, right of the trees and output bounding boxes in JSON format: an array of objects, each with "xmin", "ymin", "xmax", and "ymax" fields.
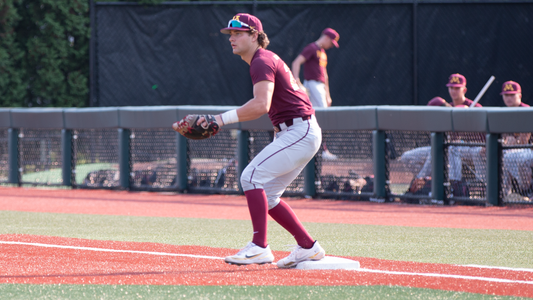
[{"xmin": 90, "ymin": 2, "xmax": 533, "ymax": 106}]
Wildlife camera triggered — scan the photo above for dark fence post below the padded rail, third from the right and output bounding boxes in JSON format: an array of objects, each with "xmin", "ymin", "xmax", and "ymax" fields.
[{"xmin": 372, "ymin": 130, "xmax": 387, "ymax": 198}]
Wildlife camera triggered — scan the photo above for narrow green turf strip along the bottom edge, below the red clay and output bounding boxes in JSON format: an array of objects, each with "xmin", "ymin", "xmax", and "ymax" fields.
[{"xmin": 0, "ymin": 284, "xmax": 524, "ymax": 300}]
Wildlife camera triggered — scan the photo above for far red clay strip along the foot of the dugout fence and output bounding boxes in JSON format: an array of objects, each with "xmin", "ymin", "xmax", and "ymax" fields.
[{"xmin": 0, "ymin": 187, "xmax": 533, "ymax": 230}]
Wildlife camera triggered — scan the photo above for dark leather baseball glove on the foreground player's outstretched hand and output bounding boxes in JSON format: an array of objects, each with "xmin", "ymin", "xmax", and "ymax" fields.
[{"xmin": 172, "ymin": 115, "xmax": 220, "ymax": 140}]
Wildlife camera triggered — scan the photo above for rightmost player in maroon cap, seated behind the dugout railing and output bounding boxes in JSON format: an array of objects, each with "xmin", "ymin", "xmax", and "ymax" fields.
[{"xmin": 500, "ymin": 81, "xmax": 533, "ymax": 201}]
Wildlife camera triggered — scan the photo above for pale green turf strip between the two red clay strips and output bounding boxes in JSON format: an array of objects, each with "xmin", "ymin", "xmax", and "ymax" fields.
[{"xmin": 0, "ymin": 211, "xmax": 533, "ymax": 268}]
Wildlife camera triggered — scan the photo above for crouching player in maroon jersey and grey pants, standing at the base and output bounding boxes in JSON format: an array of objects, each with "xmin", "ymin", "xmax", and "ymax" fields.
[{"xmin": 208, "ymin": 13, "xmax": 325, "ymax": 268}]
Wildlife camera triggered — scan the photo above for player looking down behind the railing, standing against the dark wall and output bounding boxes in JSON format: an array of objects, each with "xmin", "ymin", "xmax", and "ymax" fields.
[{"xmin": 292, "ymin": 28, "xmax": 340, "ymax": 107}]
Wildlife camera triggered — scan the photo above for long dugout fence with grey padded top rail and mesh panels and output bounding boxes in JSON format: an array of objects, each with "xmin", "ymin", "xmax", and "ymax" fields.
[{"xmin": 0, "ymin": 106, "xmax": 533, "ymax": 205}]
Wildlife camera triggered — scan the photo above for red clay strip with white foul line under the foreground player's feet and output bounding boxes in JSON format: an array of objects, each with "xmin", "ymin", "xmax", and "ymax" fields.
[{"xmin": 0, "ymin": 235, "xmax": 533, "ymax": 297}]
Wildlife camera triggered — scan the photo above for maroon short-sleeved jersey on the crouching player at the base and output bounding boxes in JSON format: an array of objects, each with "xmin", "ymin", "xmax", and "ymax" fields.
[{"xmin": 250, "ymin": 48, "xmax": 315, "ymax": 125}]
